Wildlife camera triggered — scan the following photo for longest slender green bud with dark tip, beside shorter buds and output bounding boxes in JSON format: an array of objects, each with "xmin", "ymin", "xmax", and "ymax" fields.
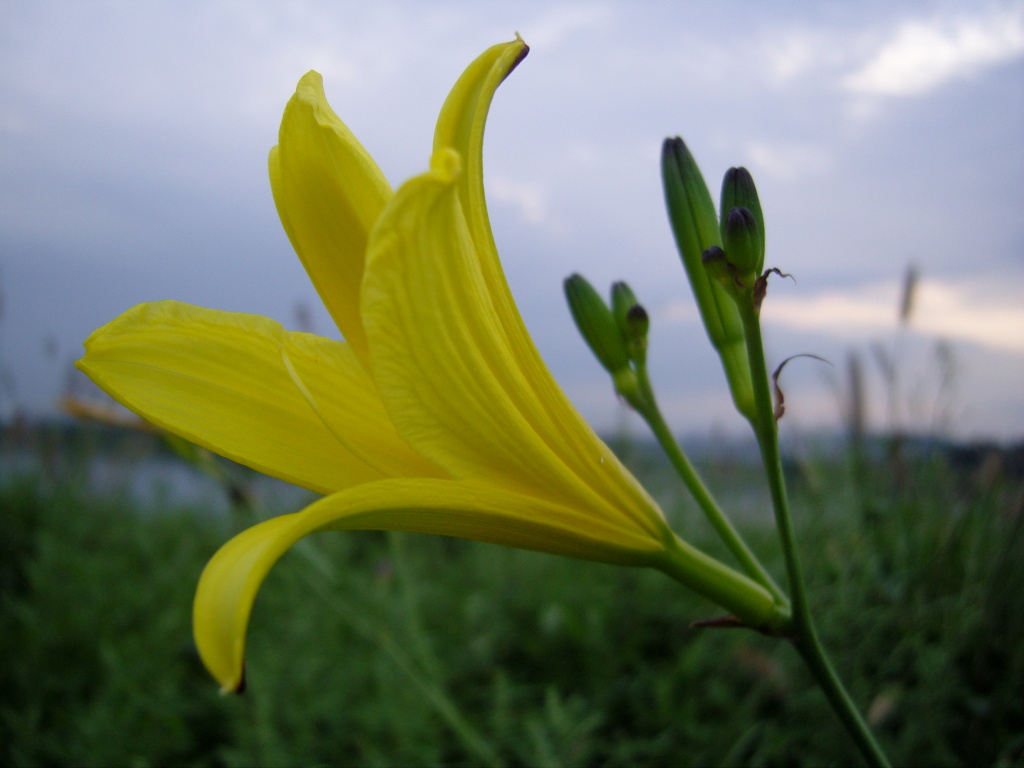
[{"xmin": 662, "ymin": 138, "xmax": 756, "ymax": 428}]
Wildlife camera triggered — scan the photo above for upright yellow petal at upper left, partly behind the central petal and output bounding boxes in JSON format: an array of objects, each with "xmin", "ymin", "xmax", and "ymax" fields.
[{"xmin": 269, "ymin": 72, "xmax": 391, "ymax": 359}]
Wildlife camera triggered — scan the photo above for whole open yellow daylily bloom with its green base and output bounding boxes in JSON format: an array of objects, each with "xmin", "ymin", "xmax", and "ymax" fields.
[{"xmin": 78, "ymin": 39, "xmax": 786, "ymax": 690}]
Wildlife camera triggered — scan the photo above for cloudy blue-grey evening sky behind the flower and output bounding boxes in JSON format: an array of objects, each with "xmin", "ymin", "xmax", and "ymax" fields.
[{"xmin": 0, "ymin": 0, "xmax": 1024, "ymax": 441}]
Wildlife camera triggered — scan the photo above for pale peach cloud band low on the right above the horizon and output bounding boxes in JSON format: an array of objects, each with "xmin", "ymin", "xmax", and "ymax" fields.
[{"xmin": 763, "ymin": 281, "xmax": 1024, "ymax": 352}]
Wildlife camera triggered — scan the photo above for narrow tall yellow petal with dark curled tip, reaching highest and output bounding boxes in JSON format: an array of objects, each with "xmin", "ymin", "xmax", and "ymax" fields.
[{"xmin": 425, "ymin": 38, "xmax": 653, "ymax": 536}]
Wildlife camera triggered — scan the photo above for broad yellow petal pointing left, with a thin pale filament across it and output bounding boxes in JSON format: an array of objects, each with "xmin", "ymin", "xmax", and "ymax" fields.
[{"xmin": 77, "ymin": 301, "xmax": 438, "ymax": 493}]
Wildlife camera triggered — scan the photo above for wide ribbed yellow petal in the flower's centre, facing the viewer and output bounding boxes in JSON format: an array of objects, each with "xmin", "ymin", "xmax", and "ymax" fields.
[{"xmin": 362, "ymin": 151, "xmax": 668, "ymax": 538}]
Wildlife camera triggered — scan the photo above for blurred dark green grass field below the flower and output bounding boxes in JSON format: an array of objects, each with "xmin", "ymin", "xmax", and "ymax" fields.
[{"xmin": 0, "ymin": 430, "xmax": 1024, "ymax": 766}]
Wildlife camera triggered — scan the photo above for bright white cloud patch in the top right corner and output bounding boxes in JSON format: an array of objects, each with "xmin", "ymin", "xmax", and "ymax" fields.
[{"xmin": 843, "ymin": 5, "xmax": 1024, "ymax": 96}]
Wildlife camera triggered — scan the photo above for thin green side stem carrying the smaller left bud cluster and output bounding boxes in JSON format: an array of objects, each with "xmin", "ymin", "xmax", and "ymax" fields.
[{"xmin": 633, "ymin": 362, "xmax": 790, "ymax": 605}]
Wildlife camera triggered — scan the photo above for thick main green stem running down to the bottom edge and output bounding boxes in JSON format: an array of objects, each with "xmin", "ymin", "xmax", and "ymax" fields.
[{"xmin": 737, "ymin": 301, "xmax": 889, "ymax": 767}]
